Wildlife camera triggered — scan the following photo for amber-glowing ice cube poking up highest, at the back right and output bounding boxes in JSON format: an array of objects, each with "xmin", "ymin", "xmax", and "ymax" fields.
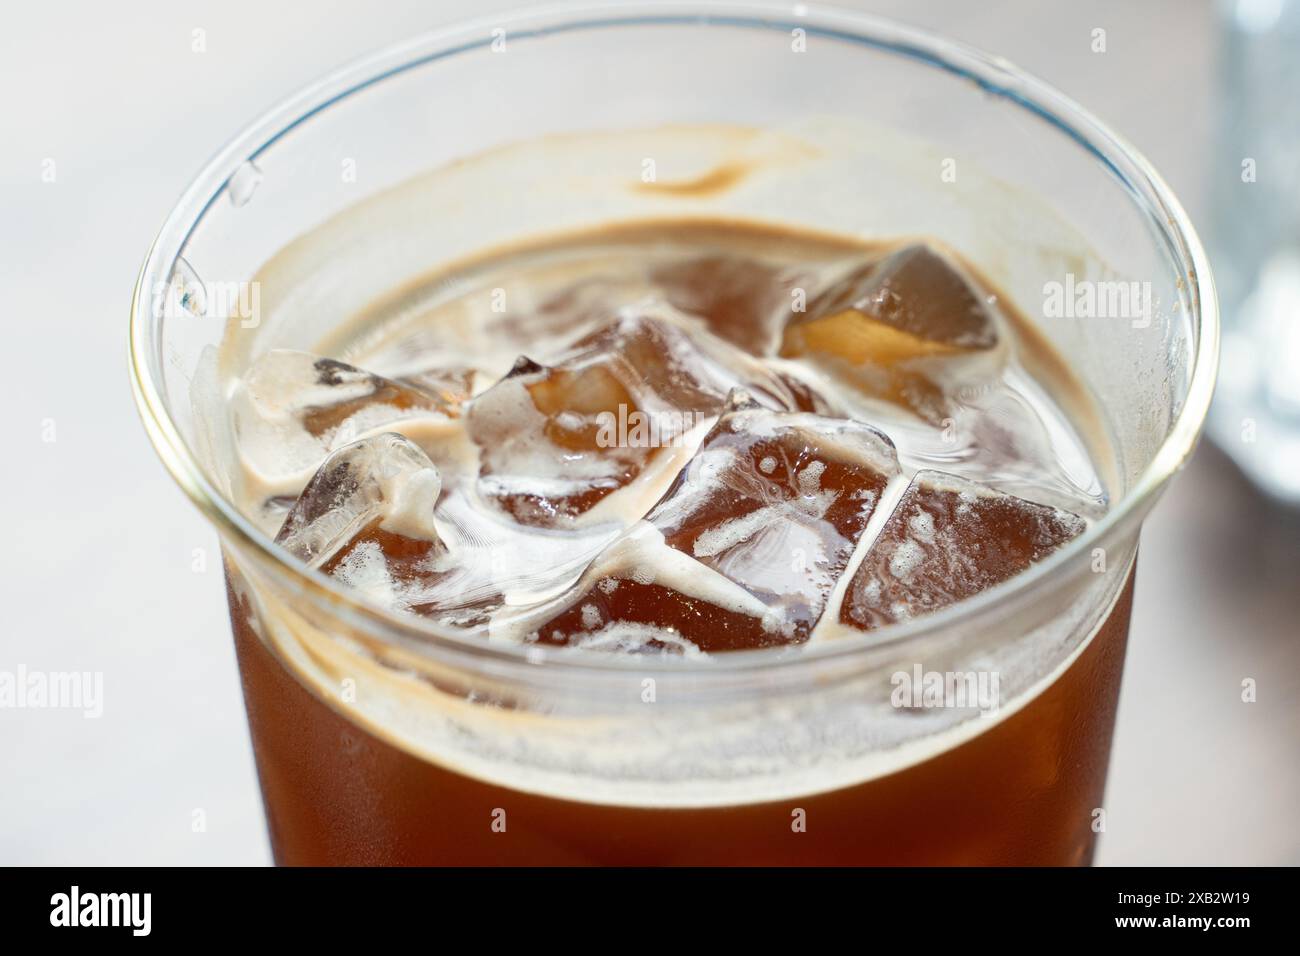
[{"xmin": 780, "ymin": 245, "xmax": 1000, "ymax": 424}]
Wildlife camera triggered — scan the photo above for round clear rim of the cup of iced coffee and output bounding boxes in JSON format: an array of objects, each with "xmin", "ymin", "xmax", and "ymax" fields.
[{"xmin": 129, "ymin": 0, "xmax": 1219, "ymax": 675}]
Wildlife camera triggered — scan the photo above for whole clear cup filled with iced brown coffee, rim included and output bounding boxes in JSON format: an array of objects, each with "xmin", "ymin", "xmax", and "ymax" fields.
[{"xmin": 131, "ymin": 1, "xmax": 1217, "ymax": 865}]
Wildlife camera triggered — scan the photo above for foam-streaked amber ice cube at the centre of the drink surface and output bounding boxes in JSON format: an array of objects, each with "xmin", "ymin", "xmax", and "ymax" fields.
[{"xmin": 467, "ymin": 311, "xmax": 801, "ymax": 527}]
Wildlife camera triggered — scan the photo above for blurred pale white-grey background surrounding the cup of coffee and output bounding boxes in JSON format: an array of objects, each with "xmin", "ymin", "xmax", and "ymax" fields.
[{"xmin": 0, "ymin": 0, "xmax": 1300, "ymax": 864}]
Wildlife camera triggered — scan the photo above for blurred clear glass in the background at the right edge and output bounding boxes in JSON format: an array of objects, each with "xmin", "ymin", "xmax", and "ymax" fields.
[{"xmin": 1208, "ymin": 0, "xmax": 1300, "ymax": 505}]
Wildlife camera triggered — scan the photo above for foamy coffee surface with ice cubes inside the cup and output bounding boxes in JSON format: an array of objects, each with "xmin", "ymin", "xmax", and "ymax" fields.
[{"xmin": 220, "ymin": 221, "xmax": 1106, "ymax": 656}]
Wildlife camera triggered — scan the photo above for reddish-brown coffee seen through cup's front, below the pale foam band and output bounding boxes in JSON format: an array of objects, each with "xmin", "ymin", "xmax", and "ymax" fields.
[{"xmin": 230, "ymin": 575, "xmax": 1132, "ymax": 866}]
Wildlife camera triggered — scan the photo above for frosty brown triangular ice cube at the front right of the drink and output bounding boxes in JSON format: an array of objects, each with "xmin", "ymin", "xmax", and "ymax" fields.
[{"xmin": 840, "ymin": 471, "xmax": 1087, "ymax": 631}]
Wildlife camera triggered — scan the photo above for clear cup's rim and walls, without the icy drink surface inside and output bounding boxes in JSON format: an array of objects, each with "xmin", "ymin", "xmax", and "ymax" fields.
[{"xmin": 131, "ymin": 3, "xmax": 1218, "ymax": 864}]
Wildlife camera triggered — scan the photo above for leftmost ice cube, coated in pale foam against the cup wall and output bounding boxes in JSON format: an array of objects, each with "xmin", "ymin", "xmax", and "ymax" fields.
[{"xmin": 230, "ymin": 349, "xmax": 462, "ymax": 515}]
